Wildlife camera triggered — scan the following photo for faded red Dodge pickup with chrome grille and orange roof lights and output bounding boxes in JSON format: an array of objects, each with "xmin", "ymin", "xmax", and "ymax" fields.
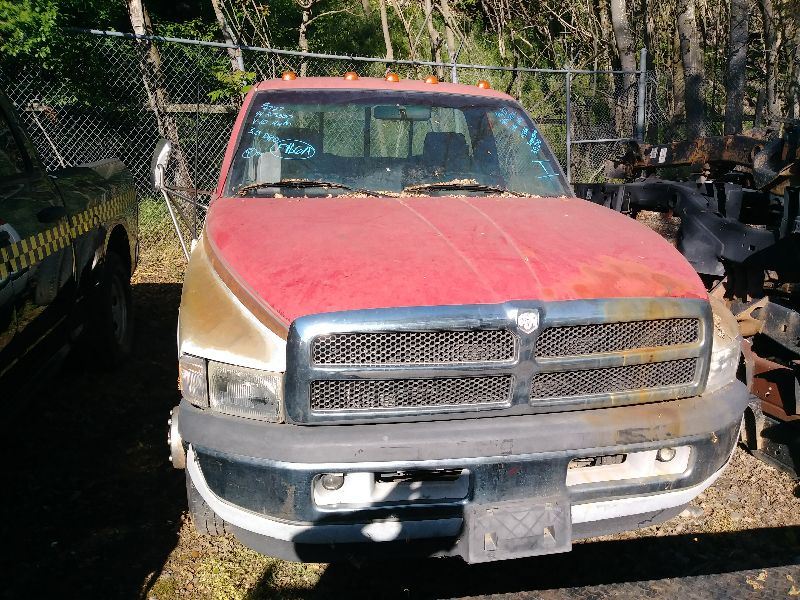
[{"xmin": 170, "ymin": 74, "xmax": 748, "ymax": 562}]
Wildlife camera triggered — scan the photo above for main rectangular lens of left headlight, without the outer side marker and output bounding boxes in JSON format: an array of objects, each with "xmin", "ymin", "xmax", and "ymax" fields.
[{"xmin": 208, "ymin": 360, "xmax": 283, "ymax": 423}]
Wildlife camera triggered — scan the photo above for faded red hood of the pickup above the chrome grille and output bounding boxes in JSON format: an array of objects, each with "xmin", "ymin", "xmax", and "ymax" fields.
[{"xmin": 206, "ymin": 196, "xmax": 707, "ymax": 324}]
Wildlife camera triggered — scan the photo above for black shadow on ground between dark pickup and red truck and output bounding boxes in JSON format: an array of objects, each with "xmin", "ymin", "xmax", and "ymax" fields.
[{"xmin": 0, "ymin": 283, "xmax": 186, "ymax": 598}]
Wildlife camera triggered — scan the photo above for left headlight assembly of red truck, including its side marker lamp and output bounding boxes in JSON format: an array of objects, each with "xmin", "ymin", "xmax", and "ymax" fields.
[{"xmin": 178, "ymin": 354, "xmax": 283, "ymax": 423}]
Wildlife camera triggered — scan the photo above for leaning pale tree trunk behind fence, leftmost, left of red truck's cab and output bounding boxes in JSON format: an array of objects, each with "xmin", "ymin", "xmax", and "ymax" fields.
[{"xmin": 127, "ymin": 0, "xmax": 194, "ymax": 188}]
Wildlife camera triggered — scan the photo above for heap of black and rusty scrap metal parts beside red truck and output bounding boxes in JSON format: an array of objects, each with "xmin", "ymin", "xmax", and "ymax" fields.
[{"xmin": 574, "ymin": 129, "xmax": 800, "ymax": 476}]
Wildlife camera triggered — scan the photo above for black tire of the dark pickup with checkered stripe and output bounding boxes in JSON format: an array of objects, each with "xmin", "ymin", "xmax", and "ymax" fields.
[{"xmin": 89, "ymin": 252, "xmax": 133, "ymax": 368}]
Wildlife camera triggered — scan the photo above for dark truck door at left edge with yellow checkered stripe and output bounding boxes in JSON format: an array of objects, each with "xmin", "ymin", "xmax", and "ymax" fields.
[{"xmin": 0, "ymin": 103, "xmax": 74, "ymax": 374}]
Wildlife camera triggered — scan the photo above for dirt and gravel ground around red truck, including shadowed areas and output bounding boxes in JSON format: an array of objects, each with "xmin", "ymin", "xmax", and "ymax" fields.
[{"xmin": 0, "ymin": 204, "xmax": 800, "ymax": 600}]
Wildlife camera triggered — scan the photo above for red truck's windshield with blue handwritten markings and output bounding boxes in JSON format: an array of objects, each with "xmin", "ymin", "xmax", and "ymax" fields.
[{"xmin": 226, "ymin": 90, "xmax": 568, "ymax": 196}]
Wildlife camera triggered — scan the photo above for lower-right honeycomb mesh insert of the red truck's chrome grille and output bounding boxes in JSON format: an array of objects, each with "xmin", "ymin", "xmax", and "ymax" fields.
[{"xmin": 531, "ymin": 358, "xmax": 697, "ymax": 399}]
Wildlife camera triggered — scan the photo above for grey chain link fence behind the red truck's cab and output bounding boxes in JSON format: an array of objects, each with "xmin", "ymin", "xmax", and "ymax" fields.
[{"xmin": 0, "ymin": 31, "xmax": 642, "ymax": 225}]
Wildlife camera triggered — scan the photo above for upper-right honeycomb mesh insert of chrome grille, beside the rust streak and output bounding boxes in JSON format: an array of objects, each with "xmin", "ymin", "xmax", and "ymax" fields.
[{"xmin": 536, "ymin": 319, "xmax": 700, "ymax": 357}]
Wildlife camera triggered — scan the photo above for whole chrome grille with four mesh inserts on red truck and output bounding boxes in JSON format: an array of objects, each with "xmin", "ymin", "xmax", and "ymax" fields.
[{"xmin": 284, "ymin": 298, "xmax": 712, "ymax": 424}]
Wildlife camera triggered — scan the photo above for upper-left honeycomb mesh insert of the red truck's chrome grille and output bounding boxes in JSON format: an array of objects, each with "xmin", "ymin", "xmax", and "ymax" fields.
[{"xmin": 312, "ymin": 329, "xmax": 515, "ymax": 365}]
